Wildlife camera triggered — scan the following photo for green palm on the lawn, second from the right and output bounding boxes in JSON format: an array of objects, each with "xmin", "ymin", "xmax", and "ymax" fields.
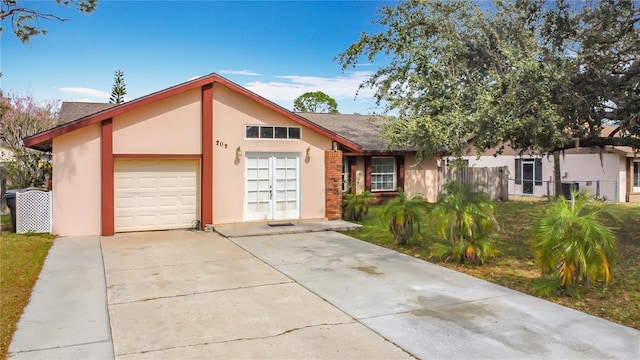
[{"xmin": 429, "ymin": 181, "xmax": 498, "ymax": 265}]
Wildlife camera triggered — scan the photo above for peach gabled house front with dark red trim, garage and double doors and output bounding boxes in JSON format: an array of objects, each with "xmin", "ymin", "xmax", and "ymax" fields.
[{"xmin": 24, "ymin": 74, "xmax": 364, "ymax": 236}]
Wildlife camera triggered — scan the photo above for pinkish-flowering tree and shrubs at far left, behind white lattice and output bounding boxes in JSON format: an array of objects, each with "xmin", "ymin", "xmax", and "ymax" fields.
[{"xmin": 0, "ymin": 93, "xmax": 57, "ymax": 188}]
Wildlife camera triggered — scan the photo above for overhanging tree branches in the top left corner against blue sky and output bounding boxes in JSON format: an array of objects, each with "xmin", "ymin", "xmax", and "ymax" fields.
[{"xmin": 0, "ymin": 0, "xmax": 98, "ymax": 43}]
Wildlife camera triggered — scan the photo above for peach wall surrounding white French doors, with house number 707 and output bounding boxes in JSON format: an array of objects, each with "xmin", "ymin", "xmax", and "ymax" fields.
[{"xmin": 213, "ymin": 84, "xmax": 332, "ymax": 224}]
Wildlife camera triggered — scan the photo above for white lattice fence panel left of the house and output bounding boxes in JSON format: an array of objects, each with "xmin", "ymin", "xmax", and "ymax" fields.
[{"xmin": 16, "ymin": 190, "xmax": 53, "ymax": 234}]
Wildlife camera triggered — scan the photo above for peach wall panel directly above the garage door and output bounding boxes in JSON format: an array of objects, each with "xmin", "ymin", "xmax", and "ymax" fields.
[{"xmin": 113, "ymin": 89, "xmax": 202, "ymax": 154}]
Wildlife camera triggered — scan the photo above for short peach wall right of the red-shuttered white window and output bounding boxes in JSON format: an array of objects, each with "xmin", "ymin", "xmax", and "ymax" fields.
[{"xmin": 404, "ymin": 155, "xmax": 438, "ymax": 202}]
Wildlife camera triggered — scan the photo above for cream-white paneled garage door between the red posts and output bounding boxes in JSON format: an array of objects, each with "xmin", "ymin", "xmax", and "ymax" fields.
[{"xmin": 114, "ymin": 159, "xmax": 199, "ymax": 232}]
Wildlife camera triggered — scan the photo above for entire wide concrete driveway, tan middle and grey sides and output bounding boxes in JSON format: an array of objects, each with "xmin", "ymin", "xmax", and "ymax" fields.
[{"xmin": 9, "ymin": 229, "xmax": 640, "ymax": 359}]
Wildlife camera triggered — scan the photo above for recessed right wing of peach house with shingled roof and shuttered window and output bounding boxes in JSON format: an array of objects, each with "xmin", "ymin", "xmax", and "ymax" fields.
[{"xmin": 298, "ymin": 113, "xmax": 438, "ymax": 201}]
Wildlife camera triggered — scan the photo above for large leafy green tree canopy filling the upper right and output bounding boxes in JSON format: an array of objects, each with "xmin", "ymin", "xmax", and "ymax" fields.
[{"xmin": 337, "ymin": 0, "xmax": 640, "ymax": 156}]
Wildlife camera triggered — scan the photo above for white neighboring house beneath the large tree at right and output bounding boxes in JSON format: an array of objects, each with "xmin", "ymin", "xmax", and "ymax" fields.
[{"xmin": 463, "ymin": 126, "xmax": 640, "ymax": 202}]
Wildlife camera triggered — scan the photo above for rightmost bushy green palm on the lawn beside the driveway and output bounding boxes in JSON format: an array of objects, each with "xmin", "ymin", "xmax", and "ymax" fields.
[{"xmin": 532, "ymin": 192, "xmax": 616, "ymax": 288}]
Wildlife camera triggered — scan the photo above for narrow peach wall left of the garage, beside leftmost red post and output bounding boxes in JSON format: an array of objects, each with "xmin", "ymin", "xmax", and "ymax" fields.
[{"xmin": 52, "ymin": 123, "xmax": 102, "ymax": 236}]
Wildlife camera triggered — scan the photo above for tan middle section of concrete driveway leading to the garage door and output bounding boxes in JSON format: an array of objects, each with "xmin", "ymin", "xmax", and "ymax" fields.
[{"xmin": 102, "ymin": 231, "xmax": 409, "ymax": 359}]
